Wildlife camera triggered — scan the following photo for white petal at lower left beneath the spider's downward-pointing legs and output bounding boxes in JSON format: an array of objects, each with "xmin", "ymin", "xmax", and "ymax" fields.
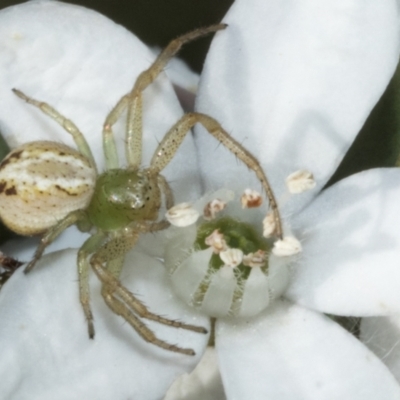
[{"xmin": 0, "ymin": 250, "xmax": 209, "ymax": 400}]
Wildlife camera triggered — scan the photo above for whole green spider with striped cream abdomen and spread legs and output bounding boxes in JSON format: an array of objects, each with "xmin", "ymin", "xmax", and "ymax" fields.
[{"xmin": 0, "ymin": 24, "xmax": 282, "ymax": 355}]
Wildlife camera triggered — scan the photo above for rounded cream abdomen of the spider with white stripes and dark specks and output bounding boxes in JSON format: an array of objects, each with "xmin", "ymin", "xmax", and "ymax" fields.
[{"xmin": 0, "ymin": 141, "xmax": 96, "ymax": 235}]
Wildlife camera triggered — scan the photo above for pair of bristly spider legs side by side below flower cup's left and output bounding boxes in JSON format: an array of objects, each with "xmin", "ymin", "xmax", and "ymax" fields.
[{"xmin": 90, "ymin": 232, "xmax": 207, "ymax": 355}]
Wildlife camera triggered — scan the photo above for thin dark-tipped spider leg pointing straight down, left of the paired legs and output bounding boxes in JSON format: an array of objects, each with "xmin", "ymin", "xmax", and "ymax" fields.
[{"xmin": 77, "ymin": 232, "xmax": 107, "ymax": 339}]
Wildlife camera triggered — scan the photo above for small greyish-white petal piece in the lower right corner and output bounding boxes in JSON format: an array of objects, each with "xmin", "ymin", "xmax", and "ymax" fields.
[{"xmin": 360, "ymin": 315, "xmax": 400, "ymax": 382}]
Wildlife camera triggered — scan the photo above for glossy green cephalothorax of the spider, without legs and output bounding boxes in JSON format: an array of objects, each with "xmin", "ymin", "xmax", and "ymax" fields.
[{"xmin": 87, "ymin": 169, "xmax": 161, "ymax": 231}]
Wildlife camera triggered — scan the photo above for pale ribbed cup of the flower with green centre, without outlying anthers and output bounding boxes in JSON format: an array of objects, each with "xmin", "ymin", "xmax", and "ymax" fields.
[{"xmin": 165, "ymin": 216, "xmax": 289, "ymax": 317}]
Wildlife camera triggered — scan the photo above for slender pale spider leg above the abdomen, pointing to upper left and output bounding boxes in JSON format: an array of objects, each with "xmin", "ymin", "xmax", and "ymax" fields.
[{"xmin": 12, "ymin": 89, "xmax": 96, "ymax": 170}]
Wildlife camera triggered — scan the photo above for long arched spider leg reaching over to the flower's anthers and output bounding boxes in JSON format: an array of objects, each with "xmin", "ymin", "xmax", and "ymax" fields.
[{"xmin": 149, "ymin": 113, "xmax": 282, "ymax": 238}]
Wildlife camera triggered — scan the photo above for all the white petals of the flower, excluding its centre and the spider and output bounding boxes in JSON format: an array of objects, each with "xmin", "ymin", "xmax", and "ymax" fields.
[{"xmin": 0, "ymin": 0, "xmax": 400, "ymax": 400}]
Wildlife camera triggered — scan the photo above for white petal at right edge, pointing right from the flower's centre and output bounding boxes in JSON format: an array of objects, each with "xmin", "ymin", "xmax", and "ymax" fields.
[{"xmin": 286, "ymin": 168, "xmax": 400, "ymax": 316}]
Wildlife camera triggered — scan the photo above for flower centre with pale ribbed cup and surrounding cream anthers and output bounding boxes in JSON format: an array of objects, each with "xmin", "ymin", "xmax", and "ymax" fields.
[{"xmin": 164, "ymin": 171, "xmax": 315, "ymax": 318}]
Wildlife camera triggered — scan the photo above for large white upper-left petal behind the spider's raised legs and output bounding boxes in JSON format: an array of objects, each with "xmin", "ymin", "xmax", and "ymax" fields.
[{"xmin": 0, "ymin": 0, "xmax": 200, "ymax": 201}]
